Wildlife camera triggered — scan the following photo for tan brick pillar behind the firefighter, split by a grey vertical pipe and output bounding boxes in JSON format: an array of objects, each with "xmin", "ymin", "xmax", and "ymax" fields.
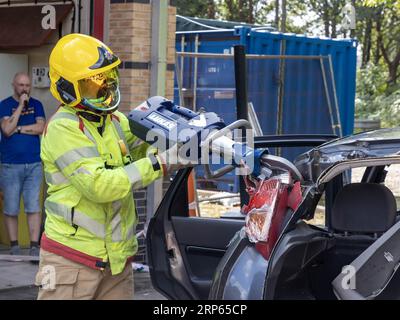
[{"xmin": 108, "ymin": 0, "xmax": 176, "ymax": 262}]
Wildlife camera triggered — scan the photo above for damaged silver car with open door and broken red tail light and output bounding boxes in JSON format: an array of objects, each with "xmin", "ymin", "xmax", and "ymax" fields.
[{"xmin": 147, "ymin": 128, "xmax": 400, "ymax": 300}]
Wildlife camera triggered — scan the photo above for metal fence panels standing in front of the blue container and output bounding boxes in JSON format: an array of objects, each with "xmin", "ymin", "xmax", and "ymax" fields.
[{"xmin": 175, "ymin": 52, "xmax": 342, "ymax": 191}]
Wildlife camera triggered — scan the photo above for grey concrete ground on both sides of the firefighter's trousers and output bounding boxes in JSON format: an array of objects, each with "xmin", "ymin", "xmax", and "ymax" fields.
[{"xmin": 0, "ymin": 249, "xmax": 166, "ymax": 300}]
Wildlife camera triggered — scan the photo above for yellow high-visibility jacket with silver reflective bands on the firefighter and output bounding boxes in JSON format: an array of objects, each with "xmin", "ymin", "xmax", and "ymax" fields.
[{"xmin": 41, "ymin": 106, "xmax": 164, "ymax": 274}]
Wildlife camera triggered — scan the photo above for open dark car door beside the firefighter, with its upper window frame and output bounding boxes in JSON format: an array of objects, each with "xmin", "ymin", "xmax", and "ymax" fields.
[{"xmin": 146, "ymin": 135, "xmax": 334, "ymax": 299}]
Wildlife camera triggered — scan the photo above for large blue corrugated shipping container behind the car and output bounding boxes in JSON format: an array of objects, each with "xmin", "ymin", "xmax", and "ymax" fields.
[{"xmin": 174, "ymin": 27, "xmax": 357, "ymax": 191}]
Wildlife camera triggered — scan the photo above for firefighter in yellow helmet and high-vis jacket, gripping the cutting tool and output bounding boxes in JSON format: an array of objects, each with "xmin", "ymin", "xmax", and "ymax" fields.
[{"xmin": 36, "ymin": 34, "xmax": 189, "ymax": 299}]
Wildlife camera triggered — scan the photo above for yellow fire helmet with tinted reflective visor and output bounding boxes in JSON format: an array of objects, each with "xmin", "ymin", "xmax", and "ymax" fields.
[{"xmin": 49, "ymin": 33, "xmax": 121, "ymax": 114}]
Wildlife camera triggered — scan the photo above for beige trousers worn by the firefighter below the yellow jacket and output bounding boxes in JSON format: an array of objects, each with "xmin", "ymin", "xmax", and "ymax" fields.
[{"xmin": 35, "ymin": 249, "xmax": 134, "ymax": 300}]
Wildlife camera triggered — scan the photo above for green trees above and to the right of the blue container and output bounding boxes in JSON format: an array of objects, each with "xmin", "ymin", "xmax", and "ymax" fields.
[{"xmin": 176, "ymin": 0, "xmax": 400, "ymax": 126}]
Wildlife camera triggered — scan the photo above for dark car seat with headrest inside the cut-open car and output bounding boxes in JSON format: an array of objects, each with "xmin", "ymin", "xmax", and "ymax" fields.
[{"xmin": 267, "ymin": 179, "xmax": 397, "ymax": 299}]
